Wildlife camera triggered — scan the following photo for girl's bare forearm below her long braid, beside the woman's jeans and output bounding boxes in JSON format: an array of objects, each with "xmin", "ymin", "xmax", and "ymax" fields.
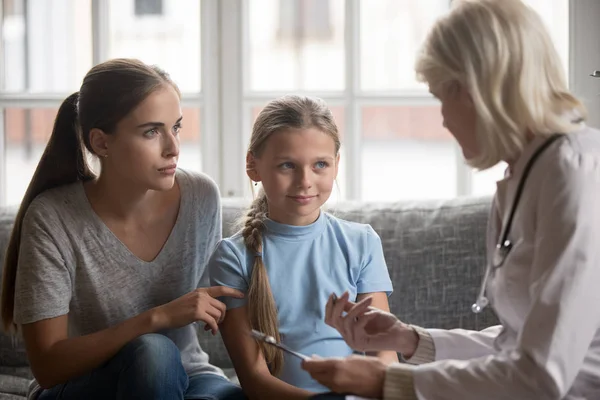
[{"xmin": 221, "ymin": 306, "xmax": 314, "ymax": 400}]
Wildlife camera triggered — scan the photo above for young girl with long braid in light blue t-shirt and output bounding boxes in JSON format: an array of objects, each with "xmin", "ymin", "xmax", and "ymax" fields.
[{"xmin": 209, "ymin": 96, "xmax": 397, "ymax": 399}]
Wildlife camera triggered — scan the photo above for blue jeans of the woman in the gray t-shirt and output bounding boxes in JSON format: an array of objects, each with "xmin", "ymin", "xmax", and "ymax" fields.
[{"xmin": 38, "ymin": 334, "xmax": 246, "ymax": 400}]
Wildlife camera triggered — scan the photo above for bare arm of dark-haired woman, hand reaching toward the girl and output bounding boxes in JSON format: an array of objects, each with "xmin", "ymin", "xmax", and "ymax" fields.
[{"xmin": 22, "ymin": 287, "xmax": 243, "ymax": 388}]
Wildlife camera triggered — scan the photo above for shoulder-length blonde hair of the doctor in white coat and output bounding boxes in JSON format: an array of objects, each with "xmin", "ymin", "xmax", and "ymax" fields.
[{"xmin": 415, "ymin": 0, "xmax": 585, "ymax": 169}]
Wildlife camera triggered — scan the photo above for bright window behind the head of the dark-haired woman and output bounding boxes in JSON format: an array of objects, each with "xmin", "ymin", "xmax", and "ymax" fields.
[{"xmin": 0, "ymin": 0, "xmax": 204, "ymax": 204}]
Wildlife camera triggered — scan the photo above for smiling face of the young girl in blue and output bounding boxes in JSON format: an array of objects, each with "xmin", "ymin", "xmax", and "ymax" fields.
[{"xmin": 247, "ymin": 128, "xmax": 339, "ymax": 225}]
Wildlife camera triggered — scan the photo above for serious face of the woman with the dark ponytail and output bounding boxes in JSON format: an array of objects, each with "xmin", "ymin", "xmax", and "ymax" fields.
[{"xmin": 94, "ymin": 85, "xmax": 182, "ymax": 190}]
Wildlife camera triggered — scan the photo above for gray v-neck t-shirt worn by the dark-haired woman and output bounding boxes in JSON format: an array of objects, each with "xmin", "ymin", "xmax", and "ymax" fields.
[{"xmin": 14, "ymin": 170, "xmax": 223, "ymax": 376}]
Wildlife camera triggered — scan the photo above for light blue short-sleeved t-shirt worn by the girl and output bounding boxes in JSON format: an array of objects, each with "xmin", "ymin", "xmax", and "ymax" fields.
[{"xmin": 208, "ymin": 212, "xmax": 392, "ymax": 392}]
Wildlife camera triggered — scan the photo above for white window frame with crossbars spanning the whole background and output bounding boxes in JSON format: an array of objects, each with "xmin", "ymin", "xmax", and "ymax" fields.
[{"xmin": 0, "ymin": 0, "xmax": 600, "ymax": 206}]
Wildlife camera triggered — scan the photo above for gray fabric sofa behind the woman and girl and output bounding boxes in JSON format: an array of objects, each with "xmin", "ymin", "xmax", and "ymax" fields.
[{"xmin": 0, "ymin": 197, "xmax": 497, "ymax": 400}]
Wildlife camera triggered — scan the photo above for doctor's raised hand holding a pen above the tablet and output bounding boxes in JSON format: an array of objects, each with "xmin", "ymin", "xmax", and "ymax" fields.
[{"xmin": 325, "ymin": 292, "xmax": 419, "ymax": 358}]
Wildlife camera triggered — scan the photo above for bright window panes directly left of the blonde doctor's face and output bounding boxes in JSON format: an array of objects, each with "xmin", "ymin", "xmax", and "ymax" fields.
[{"xmin": 355, "ymin": 0, "xmax": 457, "ymax": 201}]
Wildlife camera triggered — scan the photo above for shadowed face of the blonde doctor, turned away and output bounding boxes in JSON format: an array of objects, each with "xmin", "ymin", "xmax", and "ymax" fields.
[{"xmin": 430, "ymin": 83, "xmax": 479, "ymax": 160}]
